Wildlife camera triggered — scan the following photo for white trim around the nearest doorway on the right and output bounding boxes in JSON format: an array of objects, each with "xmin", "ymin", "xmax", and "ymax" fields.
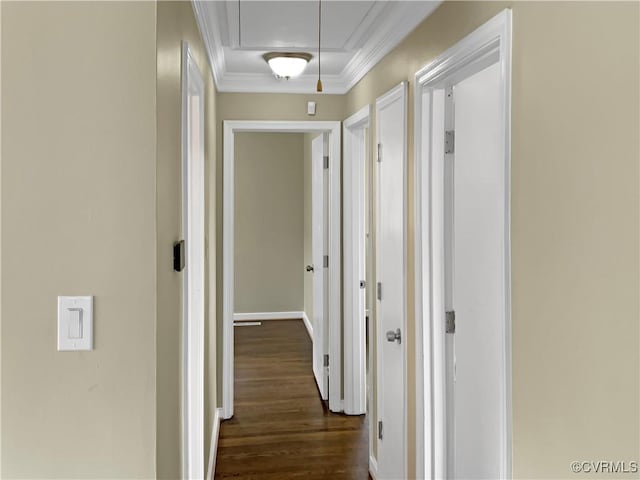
[{"xmin": 414, "ymin": 9, "xmax": 512, "ymax": 478}]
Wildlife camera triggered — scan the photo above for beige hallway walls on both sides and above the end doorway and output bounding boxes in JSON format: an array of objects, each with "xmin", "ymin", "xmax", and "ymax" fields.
[{"xmin": 6, "ymin": 1, "xmax": 640, "ymax": 478}]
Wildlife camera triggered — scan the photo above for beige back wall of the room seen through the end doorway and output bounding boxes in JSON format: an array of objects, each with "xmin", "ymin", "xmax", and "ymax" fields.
[{"xmin": 234, "ymin": 133, "xmax": 304, "ymax": 313}]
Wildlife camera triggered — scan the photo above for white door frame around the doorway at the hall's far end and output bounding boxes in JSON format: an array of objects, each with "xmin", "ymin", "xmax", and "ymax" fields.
[{"xmin": 221, "ymin": 121, "xmax": 342, "ymax": 419}]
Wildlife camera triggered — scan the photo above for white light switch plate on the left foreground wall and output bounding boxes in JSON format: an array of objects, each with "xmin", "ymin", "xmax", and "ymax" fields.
[{"xmin": 58, "ymin": 297, "xmax": 93, "ymax": 351}]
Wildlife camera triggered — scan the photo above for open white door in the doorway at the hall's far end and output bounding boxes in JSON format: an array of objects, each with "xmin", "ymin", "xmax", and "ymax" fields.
[{"xmin": 311, "ymin": 135, "xmax": 329, "ymax": 400}]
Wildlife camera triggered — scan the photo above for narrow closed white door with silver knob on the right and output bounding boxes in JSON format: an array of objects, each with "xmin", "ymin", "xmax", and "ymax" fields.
[{"xmin": 375, "ymin": 82, "xmax": 407, "ymax": 479}]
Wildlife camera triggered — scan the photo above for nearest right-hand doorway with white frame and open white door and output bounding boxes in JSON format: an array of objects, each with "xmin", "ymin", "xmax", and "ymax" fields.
[{"xmin": 414, "ymin": 10, "xmax": 511, "ymax": 478}]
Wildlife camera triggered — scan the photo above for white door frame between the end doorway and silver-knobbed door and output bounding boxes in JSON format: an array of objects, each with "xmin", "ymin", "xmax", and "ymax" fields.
[{"xmin": 342, "ymin": 105, "xmax": 371, "ymax": 415}]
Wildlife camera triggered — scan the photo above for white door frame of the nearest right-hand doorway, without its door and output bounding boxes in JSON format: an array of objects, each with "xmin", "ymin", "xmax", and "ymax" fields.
[{"xmin": 414, "ymin": 9, "xmax": 511, "ymax": 478}]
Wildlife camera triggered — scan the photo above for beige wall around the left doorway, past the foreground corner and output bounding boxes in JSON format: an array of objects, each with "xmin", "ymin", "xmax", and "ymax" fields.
[{"xmin": 156, "ymin": 1, "xmax": 216, "ymax": 478}]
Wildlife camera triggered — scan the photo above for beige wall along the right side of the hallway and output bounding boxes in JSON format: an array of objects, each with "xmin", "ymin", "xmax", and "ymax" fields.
[{"xmin": 345, "ymin": 2, "xmax": 640, "ymax": 478}]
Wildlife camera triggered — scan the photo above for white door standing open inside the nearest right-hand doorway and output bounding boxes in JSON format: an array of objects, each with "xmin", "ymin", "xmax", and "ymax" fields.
[{"xmin": 445, "ymin": 63, "xmax": 508, "ymax": 479}]
